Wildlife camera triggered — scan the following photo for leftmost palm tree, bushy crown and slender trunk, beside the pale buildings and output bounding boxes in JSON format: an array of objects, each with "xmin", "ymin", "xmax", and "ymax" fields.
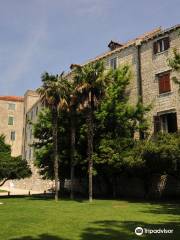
[{"xmin": 37, "ymin": 73, "xmax": 68, "ymax": 201}]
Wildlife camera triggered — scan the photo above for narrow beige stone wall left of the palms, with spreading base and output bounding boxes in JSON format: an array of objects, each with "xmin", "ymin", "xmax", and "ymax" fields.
[{"xmin": 20, "ymin": 90, "xmax": 54, "ymax": 191}]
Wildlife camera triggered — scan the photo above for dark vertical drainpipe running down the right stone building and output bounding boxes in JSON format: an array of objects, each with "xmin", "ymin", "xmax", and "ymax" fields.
[{"xmin": 136, "ymin": 39, "xmax": 144, "ymax": 139}]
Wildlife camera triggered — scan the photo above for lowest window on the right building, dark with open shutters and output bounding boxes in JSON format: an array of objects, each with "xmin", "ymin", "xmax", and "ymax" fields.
[{"xmin": 154, "ymin": 113, "xmax": 178, "ymax": 133}]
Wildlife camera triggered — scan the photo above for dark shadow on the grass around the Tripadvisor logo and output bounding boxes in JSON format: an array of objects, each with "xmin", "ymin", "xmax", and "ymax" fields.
[{"xmin": 80, "ymin": 221, "xmax": 180, "ymax": 240}]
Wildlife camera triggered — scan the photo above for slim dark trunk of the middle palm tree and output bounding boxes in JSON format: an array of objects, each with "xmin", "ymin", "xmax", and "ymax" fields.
[{"xmin": 70, "ymin": 110, "xmax": 76, "ymax": 199}]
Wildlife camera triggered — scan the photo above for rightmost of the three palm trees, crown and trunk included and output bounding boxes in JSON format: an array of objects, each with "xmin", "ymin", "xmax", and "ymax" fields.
[{"xmin": 73, "ymin": 61, "xmax": 108, "ymax": 202}]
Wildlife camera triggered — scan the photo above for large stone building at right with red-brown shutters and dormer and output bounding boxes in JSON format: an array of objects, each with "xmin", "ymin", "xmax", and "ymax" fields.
[{"xmin": 69, "ymin": 25, "xmax": 180, "ymax": 132}]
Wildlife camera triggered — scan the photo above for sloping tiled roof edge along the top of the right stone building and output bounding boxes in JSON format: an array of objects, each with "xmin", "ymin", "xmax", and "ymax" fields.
[{"xmin": 70, "ymin": 24, "xmax": 180, "ymax": 66}]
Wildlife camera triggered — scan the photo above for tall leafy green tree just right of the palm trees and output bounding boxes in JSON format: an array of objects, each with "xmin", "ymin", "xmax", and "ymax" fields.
[{"xmin": 94, "ymin": 66, "xmax": 150, "ymax": 196}]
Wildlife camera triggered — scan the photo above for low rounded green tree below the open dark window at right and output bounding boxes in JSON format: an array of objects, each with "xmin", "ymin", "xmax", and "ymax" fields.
[{"xmin": 124, "ymin": 133, "xmax": 180, "ymax": 196}]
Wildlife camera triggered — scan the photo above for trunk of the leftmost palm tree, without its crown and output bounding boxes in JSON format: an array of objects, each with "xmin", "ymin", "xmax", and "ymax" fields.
[{"xmin": 52, "ymin": 111, "xmax": 59, "ymax": 201}]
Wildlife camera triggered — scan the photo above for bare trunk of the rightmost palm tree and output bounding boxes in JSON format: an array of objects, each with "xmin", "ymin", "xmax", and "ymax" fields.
[{"xmin": 87, "ymin": 109, "xmax": 94, "ymax": 202}]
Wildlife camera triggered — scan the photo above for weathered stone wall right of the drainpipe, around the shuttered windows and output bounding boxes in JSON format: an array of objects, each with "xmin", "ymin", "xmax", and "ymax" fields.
[{"xmin": 141, "ymin": 30, "xmax": 180, "ymax": 133}]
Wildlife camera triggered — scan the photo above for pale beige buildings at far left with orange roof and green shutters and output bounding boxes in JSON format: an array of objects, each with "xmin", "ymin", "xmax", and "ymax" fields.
[{"xmin": 0, "ymin": 90, "xmax": 53, "ymax": 191}]
